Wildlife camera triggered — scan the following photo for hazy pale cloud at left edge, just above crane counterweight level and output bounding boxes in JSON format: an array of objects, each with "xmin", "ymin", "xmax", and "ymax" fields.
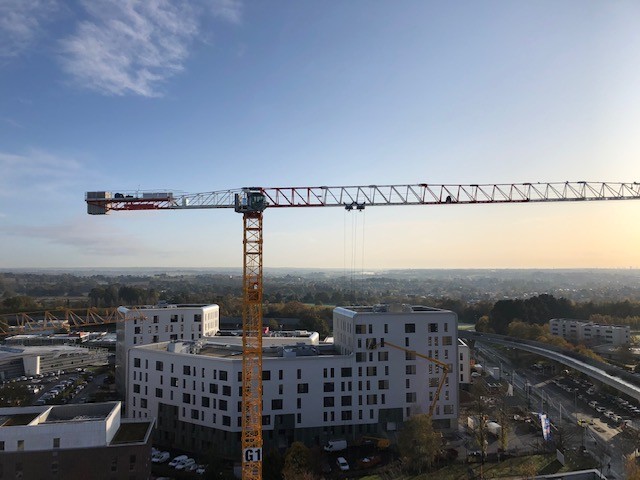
[{"xmin": 0, "ymin": 150, "xmax": 87, "ymax": 198}]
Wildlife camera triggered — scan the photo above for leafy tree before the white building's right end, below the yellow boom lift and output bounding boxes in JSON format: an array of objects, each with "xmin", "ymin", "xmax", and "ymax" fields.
[{"xmin": 398, "ymin": 413, "xmax": 442, "ymax": 473}]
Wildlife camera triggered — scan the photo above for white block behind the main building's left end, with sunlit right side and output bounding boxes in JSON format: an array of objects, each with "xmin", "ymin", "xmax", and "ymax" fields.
[{"xmin": 115, "ymin": 304, "xmax": 220, "ymax": 392}]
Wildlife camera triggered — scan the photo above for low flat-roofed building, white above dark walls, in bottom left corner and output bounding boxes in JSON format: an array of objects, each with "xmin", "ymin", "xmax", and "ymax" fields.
[{"xmin": 0, "ymin": 402, "xmax": 153, "ymax": 480}]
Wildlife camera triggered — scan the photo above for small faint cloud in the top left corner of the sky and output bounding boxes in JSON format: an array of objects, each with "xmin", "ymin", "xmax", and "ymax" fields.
[{"xmin": 0, "ymin": 0, "xmax": 58, "ymax": 58}]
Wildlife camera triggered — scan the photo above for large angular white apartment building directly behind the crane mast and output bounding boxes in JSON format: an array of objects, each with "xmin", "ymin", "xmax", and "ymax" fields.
[{"xmin": 127, "ymin": 306, "xmax": 459, "ymax": 456}]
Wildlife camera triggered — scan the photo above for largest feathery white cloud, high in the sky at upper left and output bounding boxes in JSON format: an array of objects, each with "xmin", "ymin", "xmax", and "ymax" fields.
[{"xmin": 61, "ymin": 0, "xmax": 241, "ymax": 97}]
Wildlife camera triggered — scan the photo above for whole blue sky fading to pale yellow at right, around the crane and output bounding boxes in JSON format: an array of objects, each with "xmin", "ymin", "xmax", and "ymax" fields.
[{"xmin": 0, "ymin": 0, "xmax": 640, "ymax": 269}]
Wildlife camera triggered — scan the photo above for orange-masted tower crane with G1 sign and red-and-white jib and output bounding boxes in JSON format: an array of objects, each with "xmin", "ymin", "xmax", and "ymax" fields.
[{"xmin": 85, "ymin": 181, "xmax": 640, "ymax": 480}]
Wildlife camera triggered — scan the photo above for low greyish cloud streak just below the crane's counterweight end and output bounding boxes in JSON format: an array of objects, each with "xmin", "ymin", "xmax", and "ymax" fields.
[{"xmin": 0, "ymin": 219, "xmax": 154, "ymax": 256}]
